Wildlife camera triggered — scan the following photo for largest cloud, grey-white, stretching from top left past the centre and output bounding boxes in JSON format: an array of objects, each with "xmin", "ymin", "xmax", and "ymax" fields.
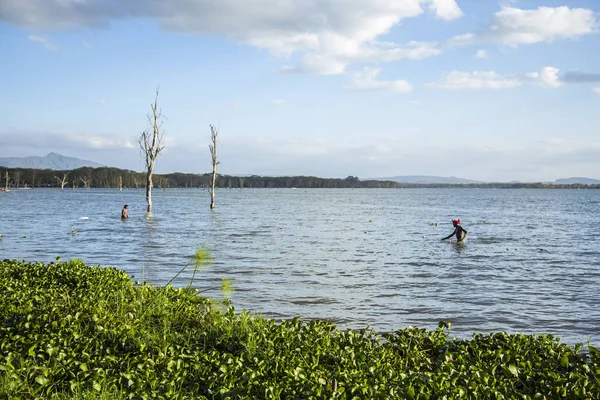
[{"xmin": 0, "ymin": 0, "xmax": 462, "ymax": 74}]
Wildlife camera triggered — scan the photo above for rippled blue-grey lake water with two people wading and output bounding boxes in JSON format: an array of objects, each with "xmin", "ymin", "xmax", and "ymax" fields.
[{"xmin": 0, "ymin": 189, "xmax": 600, "ymax": 346}]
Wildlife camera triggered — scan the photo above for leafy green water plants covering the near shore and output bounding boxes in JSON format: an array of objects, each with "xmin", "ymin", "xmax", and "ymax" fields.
[{"xmin": 0, "ymin": 258, "xmax": 600, "ymax": 399}]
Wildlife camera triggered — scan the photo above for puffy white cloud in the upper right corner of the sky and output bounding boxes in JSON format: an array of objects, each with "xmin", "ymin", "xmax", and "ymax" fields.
[{"xmin": 449, "ymin": 6, "xmax": 597, "ymax": 46}]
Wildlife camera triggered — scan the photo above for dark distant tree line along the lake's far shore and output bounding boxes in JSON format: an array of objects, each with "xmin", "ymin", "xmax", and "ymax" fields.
[{"xmin": 0, "ymin": 167, "xmax": 600, "ymax": 190}]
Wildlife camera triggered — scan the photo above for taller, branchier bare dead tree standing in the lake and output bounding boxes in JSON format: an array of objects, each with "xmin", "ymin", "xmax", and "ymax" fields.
[{"xmin": 138, "ymin": 89, "xmax": 164, "ymax": 214}]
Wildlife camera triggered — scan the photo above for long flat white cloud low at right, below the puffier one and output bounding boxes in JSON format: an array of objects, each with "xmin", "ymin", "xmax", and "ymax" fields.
[{"xmin": 427, "ymin": 67, "xmax": 563, "ymax": 90}]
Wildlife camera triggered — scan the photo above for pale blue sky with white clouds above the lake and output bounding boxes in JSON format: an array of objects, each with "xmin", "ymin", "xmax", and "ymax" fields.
[{"xmin": 0, "ymin": 0, "xmax": 600, "ymax": 182}]
